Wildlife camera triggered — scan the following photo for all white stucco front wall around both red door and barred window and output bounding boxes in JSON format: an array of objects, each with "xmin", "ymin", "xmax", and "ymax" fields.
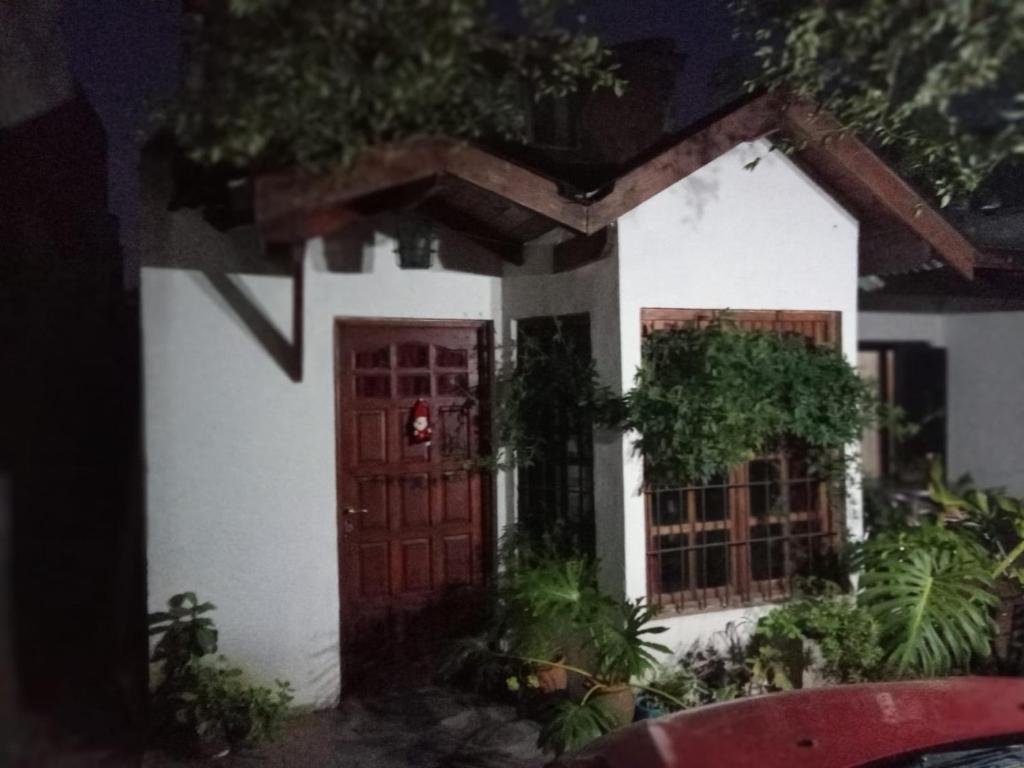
[{"xmin": 142, "ymin": 135, "xmax": 860, "ymax": 706}]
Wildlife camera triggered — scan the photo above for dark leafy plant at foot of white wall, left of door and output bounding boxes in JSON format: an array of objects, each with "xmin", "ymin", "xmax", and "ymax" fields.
[{"xmin": 150, "ymin": 592, "xmax": 293, "ymax": 749}]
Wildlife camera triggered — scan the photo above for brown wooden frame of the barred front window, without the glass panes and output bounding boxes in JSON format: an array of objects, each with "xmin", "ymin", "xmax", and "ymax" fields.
[{"xmin": 641, "ymin": 308, "xmax": 845, "ymax": 613}]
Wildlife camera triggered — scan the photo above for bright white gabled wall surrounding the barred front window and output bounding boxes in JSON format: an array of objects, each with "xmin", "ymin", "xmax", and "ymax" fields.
[{"xmin": 614, "ymin": 142, "xmax": 861, "ymax": 647}]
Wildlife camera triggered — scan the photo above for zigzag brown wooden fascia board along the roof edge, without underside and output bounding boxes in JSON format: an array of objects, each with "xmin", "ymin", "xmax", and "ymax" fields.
[{"xmin": 249, "ymin": 94, "xmax": 977, "ymax": 278}]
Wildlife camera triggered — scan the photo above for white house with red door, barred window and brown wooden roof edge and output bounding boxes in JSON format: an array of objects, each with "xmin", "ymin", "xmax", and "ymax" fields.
[{"xmin": 141, "ymin": 98, "xmax": 974, "ymax": 706}]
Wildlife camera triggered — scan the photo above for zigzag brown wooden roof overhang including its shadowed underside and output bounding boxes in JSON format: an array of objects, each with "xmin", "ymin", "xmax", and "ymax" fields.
[{"xmin": 255, "ymin": 95, "xmax": 977, "ymax": 278}]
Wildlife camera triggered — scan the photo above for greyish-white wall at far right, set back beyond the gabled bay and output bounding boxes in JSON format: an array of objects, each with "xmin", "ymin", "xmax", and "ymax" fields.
[{"xmin": 860, "ymin": 312, "xmax": 1024, "ymax": 494}]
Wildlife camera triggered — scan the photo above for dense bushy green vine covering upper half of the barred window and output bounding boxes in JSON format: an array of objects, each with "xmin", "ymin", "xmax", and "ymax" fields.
[{"xmin": 626, "ymin": 317, "xmax": 878, "ymax": 484}]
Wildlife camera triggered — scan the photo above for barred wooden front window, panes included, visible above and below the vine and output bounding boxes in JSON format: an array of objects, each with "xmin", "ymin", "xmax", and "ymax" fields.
[{"xmin": 642, "ymin": 309, "xmax": 842, "ymax": 610}]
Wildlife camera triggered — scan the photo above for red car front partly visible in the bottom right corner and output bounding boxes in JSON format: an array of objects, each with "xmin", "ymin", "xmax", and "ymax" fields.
[{"xmin": 553, "ymin": 677, "xmax": 1024, "ymax": 768}]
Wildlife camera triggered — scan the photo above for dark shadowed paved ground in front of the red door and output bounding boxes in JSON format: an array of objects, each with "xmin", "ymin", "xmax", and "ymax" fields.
[{"xmin": 144, "ymin": 688, "xmax": 546, "ymax": 768}]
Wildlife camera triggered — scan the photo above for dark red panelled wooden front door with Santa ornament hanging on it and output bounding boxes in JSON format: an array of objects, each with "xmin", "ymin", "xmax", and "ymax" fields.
[{"xmin": 336, "ymin": 321, "xmax": 490, "ymax": 691}]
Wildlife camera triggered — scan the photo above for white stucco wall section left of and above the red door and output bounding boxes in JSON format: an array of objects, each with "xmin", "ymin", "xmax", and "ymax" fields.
[{"xmin": 141, "ymin": 236, "xmax": 501, "ymax": 706}]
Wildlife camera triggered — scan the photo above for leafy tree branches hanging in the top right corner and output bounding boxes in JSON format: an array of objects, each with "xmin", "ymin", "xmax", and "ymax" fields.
[{"xmin": 734, "ymin": 0, "xmax": 1024, "ymax": 205}]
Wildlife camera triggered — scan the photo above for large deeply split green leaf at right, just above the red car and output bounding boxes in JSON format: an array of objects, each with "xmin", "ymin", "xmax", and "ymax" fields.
[{"xmin": 858, "ymin": 523, "xmax": 998, "ymax": 676}]
